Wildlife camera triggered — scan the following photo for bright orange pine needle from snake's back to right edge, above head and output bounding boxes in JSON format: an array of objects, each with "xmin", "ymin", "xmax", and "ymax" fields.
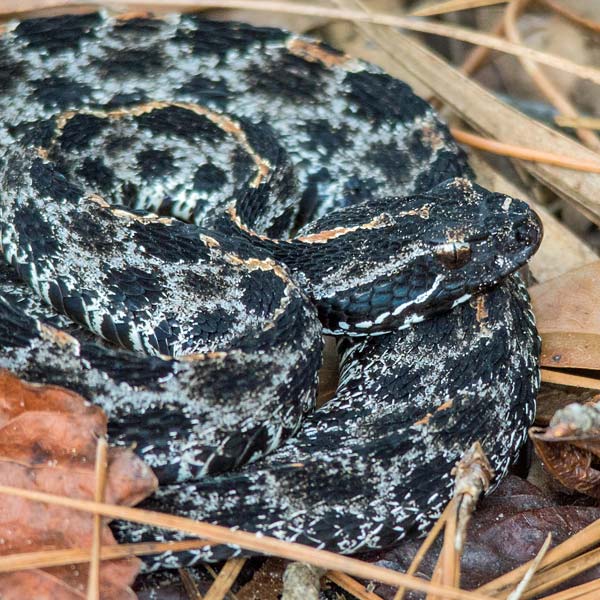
[{"xmin": 450, "ymin": 127, "xmax": 600, "ymax": 173}]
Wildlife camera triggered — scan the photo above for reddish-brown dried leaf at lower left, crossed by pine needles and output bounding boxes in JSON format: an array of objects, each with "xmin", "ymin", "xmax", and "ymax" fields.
[{"xmin": 0, "ymin": 370, "xmax": 157, "ymax": 600}]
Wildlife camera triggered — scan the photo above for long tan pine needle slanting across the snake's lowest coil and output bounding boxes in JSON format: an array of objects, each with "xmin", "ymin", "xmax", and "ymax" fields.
[{"xmin": 0, "ymin": 485, "xmax": 492, "ymax": 600}]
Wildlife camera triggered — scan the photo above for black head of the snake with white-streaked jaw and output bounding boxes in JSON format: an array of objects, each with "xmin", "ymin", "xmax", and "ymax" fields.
[{"xmin": 292, "ymin": 178, "xmax": 542, "ymax": 335}]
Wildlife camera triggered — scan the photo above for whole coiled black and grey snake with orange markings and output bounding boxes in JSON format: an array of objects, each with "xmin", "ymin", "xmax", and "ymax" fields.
[{"xmin": 0, "ymin": 13, "xmax": 541, "ymax": 569}]
